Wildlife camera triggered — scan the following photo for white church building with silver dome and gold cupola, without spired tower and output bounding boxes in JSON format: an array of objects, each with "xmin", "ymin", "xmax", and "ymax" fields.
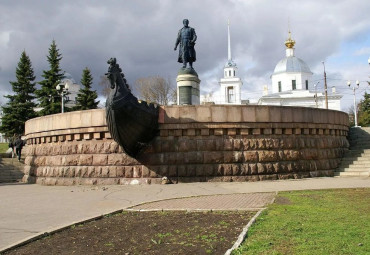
[{"xmin": 258, "ymin": 31, "xmax": 342, "ymax": 110}]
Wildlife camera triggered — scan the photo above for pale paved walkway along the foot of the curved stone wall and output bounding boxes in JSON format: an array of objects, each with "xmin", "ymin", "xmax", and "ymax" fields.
[{"xmin": 0, "ymin": 178, "xmax": 370, "ymax": 251}]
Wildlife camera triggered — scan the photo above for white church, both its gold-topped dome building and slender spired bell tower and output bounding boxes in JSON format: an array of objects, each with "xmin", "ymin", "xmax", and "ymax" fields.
[{"xmin": 201, "ymin": 24, "xmax": 342, "ymax": 110}]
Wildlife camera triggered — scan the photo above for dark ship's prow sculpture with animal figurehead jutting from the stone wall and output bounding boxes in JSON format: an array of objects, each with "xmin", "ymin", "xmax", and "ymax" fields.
[{"xmin": 106, "ymin": 58, "xmax": 159, "ymax": 158}]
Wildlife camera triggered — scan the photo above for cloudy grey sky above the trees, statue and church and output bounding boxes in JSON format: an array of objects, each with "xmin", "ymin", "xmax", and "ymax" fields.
[{"xmin": 0, "ymin": 0, "xmax": 370, "ymax": 111}]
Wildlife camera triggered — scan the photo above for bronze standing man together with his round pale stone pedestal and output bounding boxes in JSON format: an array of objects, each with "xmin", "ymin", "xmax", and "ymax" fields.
[{"xmin": 175, "ymin": 19, "xmax": 200, "ymax": 105}]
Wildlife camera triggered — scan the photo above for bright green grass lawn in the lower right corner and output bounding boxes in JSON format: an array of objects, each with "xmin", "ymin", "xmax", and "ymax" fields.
[{"xmin": 233, "ymin": 189, "xmax": 370, "ymax": 255}]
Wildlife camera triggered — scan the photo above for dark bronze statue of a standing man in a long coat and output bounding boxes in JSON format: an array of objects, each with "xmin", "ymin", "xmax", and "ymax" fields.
[{"xmin": 175, "ymin": 19, "xmax": 197, "ymax": 68}]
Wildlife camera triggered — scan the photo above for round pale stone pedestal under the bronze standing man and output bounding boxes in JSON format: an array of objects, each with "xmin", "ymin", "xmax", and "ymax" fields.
[{"xmin": 176, "ymin": 68, "xmax": 200, "ymax": 105}]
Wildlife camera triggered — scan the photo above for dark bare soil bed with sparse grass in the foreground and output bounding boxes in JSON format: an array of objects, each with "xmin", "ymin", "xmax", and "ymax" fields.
[{"xmin": 6, "ymin": 211, "xmax": 255, "ymax": 255}]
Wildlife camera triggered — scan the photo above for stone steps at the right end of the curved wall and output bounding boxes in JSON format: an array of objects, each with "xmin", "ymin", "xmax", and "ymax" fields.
[{"xmin": 334, "ymin": 128, "xmax": 370, "ymax": 177}]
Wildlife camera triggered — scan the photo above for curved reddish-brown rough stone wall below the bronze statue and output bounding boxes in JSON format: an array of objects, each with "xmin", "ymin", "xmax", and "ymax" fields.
[{"xmin": 24, "ymin": 105, "xmax": 348, "ymax": 185}]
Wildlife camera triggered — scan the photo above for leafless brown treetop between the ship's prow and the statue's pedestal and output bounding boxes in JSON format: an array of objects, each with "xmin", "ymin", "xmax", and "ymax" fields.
[{"xmin": 135, "ymin": 76, "xmax": 176, "ymax": 105}]
